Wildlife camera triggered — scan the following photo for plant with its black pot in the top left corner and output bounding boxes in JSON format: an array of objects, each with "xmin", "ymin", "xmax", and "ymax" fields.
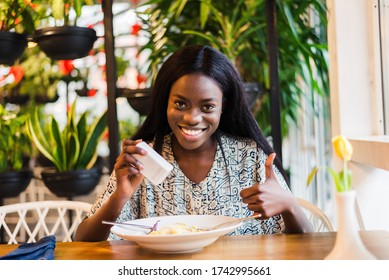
[{"xmin": 0, "ymin": 0, "xmax": 45, "ymax": 65}]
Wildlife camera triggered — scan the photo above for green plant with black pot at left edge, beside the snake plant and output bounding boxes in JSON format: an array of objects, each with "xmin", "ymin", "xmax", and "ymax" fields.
[{"xmin": 0, "ymin": 105, "xmax": 32, "ymax": 204}]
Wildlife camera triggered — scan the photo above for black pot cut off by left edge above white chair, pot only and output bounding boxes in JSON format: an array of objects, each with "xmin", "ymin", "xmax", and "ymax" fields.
[{"xmin": 0, "ymin": 170, "xmax": 32, "ymax": 201}]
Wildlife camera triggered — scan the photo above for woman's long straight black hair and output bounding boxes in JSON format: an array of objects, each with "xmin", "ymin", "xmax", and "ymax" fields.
[{"xmin": 132, "ymin": 46, "xmax": 287, "ymax": 183}]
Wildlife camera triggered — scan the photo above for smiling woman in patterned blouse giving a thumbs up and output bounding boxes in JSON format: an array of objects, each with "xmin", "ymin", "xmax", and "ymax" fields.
[{"xmin": 76, "ymin": 46, "xmax": 312, "ymax": 241}]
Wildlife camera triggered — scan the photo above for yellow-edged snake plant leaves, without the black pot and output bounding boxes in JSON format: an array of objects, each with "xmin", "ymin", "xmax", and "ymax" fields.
[{"xmin": 27, "ymin": 101, "xmax": 107, "ymax": 171}]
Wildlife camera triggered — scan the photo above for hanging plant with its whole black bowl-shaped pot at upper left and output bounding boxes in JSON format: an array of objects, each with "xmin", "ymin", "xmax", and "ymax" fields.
[{"xmin": 34, "ymin": 0, "xmax": 97, "ymax": 60}]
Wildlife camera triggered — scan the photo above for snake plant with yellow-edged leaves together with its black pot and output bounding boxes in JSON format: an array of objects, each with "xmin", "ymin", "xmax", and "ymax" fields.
[{"xmin": 26, "ymin": 99, "xmax": 107, "ymax": 198}]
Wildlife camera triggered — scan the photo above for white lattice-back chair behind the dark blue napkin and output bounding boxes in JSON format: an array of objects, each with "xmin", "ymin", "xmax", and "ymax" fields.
[{"xmin": 0, "ymin": 200, "xmax": 92, "ymax": 244}]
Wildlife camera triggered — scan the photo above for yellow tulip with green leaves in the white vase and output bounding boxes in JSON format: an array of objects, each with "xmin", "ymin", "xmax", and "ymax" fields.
[{"xmin": 307, "ymin": 135, "xmax": 353, "ymax": 192}]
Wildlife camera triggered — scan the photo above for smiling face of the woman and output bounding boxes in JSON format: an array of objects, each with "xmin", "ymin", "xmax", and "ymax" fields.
[{"xmin": 167, "ymin": 73, "xmax": 223, "ymax": 150}]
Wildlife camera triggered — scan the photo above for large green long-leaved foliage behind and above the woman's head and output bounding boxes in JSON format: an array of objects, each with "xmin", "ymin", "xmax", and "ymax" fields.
[{"xmin": 139, "ymin": 0, "xmax": 329, "ymax": 136}]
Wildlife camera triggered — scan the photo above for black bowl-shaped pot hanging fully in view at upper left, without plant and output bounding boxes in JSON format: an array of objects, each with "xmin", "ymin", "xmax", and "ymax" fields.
[{"xmin": 34, "ymin": 26, "xmax": 97, "ymax": 60}]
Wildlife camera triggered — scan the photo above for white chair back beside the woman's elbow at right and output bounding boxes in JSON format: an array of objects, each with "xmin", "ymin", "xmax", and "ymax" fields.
[{"xmin": 296, "ymin": 197, "xmax": 335, "ymax": 232}]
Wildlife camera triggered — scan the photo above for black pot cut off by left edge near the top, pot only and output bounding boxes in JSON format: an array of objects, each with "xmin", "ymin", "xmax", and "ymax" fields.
[{"xmin": 0, "ymin": 31, "xmax": 27, "ymax": 66}]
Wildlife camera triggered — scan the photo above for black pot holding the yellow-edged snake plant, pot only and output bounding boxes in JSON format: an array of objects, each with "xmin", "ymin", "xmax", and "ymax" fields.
[{"xmin": 41, "ymin": 167, "xmax": 102, "ymax": 199}]
